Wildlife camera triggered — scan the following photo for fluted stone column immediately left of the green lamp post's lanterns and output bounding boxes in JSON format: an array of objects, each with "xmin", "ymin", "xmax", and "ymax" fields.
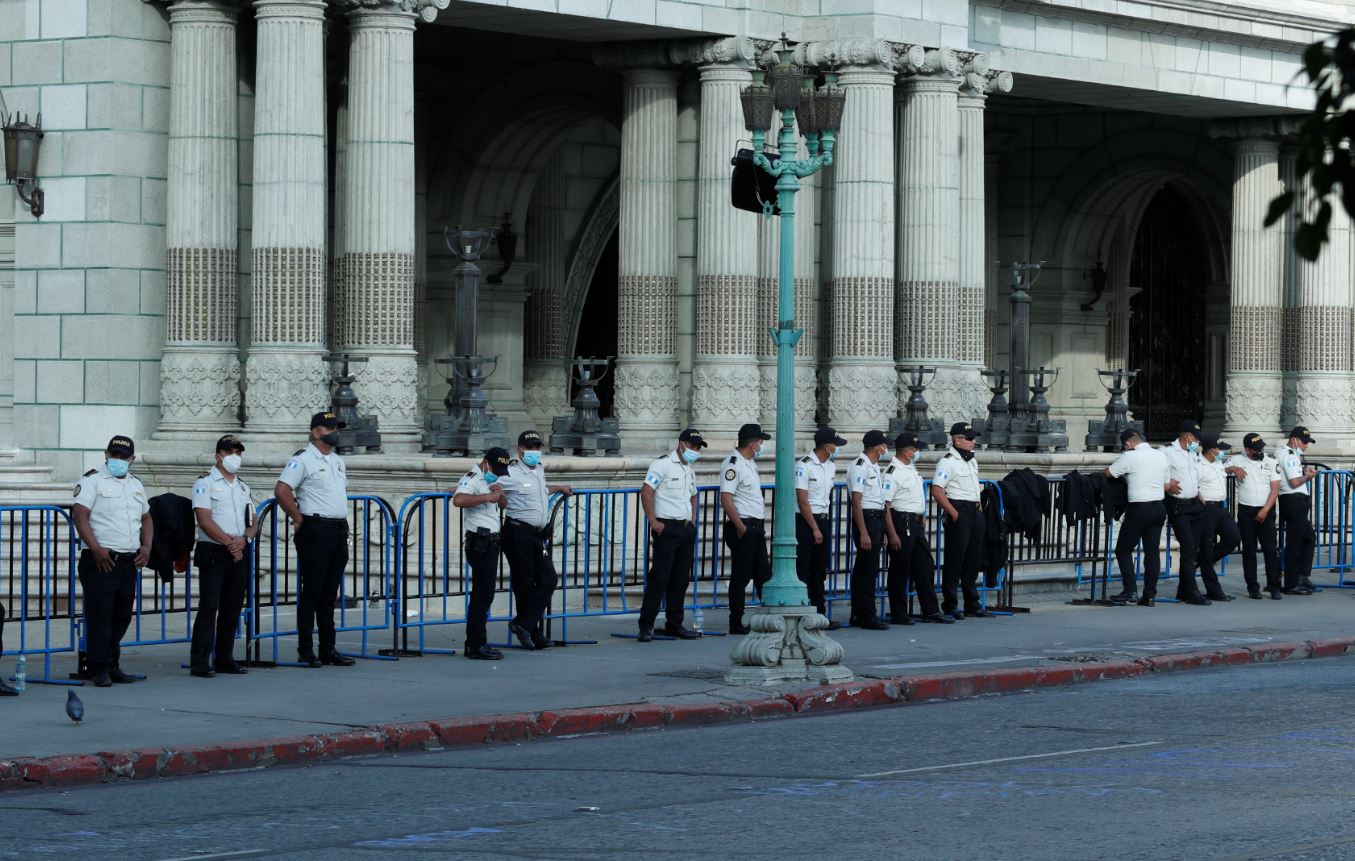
[{"xmin": 691, "ymin": 53, "xmax": 778, "ymax": 435}]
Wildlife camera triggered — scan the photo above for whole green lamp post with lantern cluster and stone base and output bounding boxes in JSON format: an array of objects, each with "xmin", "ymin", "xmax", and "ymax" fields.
[{"xmin": 725, "ymin": 34, "xmax": 852, "ymax": 683}]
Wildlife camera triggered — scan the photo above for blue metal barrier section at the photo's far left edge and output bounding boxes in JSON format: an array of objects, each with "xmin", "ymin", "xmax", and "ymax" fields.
[{"xmin": 0, "ymin": 506, "xmax": 81, "ymax": 685}]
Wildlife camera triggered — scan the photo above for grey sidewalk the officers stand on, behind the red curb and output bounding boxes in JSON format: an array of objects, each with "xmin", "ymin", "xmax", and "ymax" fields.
[{"xmin": 0, "ymin": 582, "xmax": 1355, "ymax": 788}]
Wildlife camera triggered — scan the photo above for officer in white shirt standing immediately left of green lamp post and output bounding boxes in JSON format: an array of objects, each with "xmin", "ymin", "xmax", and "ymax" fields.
[{"xmin": 720, "ymin": 424, "xmax": 771, "ymax": 633}]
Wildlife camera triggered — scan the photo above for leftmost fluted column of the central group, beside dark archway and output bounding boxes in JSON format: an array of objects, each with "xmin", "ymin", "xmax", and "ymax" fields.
[{"xmin": 614, "ymin": 69, "xmax": 678, "ymax": 450}]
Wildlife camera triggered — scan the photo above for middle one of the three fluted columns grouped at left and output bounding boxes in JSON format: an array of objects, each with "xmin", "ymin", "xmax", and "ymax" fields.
[{"xmin": 245, "ymin": 0, "xmax": 329, "ymax": 435}]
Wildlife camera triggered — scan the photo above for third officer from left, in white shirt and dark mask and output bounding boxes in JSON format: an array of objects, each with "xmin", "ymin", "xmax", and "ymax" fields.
[{"xmin": 274, "ymin": 411, "xmax": 355, "ymax": 668}]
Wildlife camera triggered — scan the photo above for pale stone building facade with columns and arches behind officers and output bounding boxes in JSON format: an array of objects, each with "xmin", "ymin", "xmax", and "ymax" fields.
[{"xmin": 0, "ymin": 0, "xmax": 1355, "ymax": 490}]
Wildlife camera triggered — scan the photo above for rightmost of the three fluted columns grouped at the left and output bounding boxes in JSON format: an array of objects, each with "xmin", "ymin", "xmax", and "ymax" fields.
[{"xmin": 333, "ymin": 3, "xmax": 419, "ymax": 443}]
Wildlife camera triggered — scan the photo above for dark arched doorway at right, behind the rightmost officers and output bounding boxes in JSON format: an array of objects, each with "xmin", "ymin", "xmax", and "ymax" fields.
[{"xmin": 1129, "ymin": 184, "xmax": 1209, "ymax": 439}]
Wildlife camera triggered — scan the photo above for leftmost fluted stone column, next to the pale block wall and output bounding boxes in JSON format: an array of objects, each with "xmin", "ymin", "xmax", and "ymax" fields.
[{"xmin": 160, "ymin": 0, "xmax": 240, "ymax": 435}]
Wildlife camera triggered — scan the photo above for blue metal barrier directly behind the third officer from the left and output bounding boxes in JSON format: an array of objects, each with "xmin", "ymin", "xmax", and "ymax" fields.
[{"xmin": 245, "ymin": 494, "xmax": 396, "ymax": 666}]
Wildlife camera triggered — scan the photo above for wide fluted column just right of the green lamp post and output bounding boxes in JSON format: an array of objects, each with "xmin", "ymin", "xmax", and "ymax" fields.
[{"xmin": 828, "ymin": 43, "xmax": 894, "ymax": 433}]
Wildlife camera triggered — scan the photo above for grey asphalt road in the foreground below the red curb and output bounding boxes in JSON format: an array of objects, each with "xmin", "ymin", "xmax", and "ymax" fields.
[{"xmin": 0, "ymin": 658, "xmax": 1355, "ymax": 861}]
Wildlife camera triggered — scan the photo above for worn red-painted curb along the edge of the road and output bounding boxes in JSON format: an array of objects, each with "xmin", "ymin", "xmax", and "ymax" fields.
[{"xmin": 0, "ymin": 637, "xmax": 1355, "ymax": 792}]
